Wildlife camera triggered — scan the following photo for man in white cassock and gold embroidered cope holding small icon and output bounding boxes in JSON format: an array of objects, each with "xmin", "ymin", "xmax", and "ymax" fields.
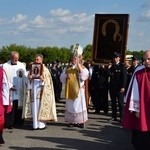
[{"xmin": 24, "ymin": 54, "xmax": 57, "ymax": 130}]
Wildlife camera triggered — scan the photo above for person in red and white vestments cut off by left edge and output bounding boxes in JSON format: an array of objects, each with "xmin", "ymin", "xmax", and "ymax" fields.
[{"xmin": 0, "ymin": 67, "xmax": 11, "ymax": 144}]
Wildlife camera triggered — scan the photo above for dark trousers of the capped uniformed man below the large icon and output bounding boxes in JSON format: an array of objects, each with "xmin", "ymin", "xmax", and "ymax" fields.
[{"xmin": 110, "ymin": 90, "xmax": 124, "ymax": 119}]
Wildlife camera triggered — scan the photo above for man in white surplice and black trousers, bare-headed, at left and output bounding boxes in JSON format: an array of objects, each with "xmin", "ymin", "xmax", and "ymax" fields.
[{"xmin": 3, "ymin": 51, "xmax": 27, "ymax": 128}]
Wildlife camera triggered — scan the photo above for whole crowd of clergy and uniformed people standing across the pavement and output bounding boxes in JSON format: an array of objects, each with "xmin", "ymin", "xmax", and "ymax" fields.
[{"xmin": 0, "ymin": 50, "xmax": 150, "ymax": 150}]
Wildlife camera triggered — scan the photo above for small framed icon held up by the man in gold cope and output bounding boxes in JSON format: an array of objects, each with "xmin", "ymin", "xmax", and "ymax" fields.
[{"xmin": 30, "ymin": 63, "xmax": 43, "ymax": 79}]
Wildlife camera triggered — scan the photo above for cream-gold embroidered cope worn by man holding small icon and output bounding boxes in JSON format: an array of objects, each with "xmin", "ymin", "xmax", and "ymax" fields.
[{"xmin": 24, "ymin": 65, "xmax": 57, "ymax": 121}]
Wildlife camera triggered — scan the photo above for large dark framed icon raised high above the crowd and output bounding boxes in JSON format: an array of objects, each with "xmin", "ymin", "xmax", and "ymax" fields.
[{"xmin": 92, "ymin": 14, "xmax": 129, "ymax": 63}]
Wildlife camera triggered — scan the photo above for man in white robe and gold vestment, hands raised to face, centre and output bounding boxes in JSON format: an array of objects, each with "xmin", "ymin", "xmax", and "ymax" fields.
[{"xmin": 60, "ymin": 57, "xmax": 89, "ymax": 128}]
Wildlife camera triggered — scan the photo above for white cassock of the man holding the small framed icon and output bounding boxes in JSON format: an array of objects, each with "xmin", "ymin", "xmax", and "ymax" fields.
[{"xmin": 29, "ymin": 79, "xmax": 46, "ymax": 129}]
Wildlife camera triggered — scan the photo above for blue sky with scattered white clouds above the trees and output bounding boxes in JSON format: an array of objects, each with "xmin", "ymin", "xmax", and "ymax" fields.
[{"xmin": 0, "ymin": 0, "xmax": 150, "ymax": 50}]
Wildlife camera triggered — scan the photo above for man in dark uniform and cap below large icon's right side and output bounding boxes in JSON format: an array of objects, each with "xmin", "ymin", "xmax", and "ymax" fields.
[{"xmin": 109, "ymin": 52, "xmax": 127, "ymax": 121}]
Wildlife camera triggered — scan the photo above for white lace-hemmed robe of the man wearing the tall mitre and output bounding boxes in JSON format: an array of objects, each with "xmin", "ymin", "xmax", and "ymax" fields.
[{"xmin": 60, "ymin": 68, "xmax": 89, "ymax": 124}]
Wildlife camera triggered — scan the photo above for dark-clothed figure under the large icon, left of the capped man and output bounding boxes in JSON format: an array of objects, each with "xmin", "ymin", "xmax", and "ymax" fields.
[{"xmin": 91, "ymin": 65, "xmax": 108, "ymax": 114}]
